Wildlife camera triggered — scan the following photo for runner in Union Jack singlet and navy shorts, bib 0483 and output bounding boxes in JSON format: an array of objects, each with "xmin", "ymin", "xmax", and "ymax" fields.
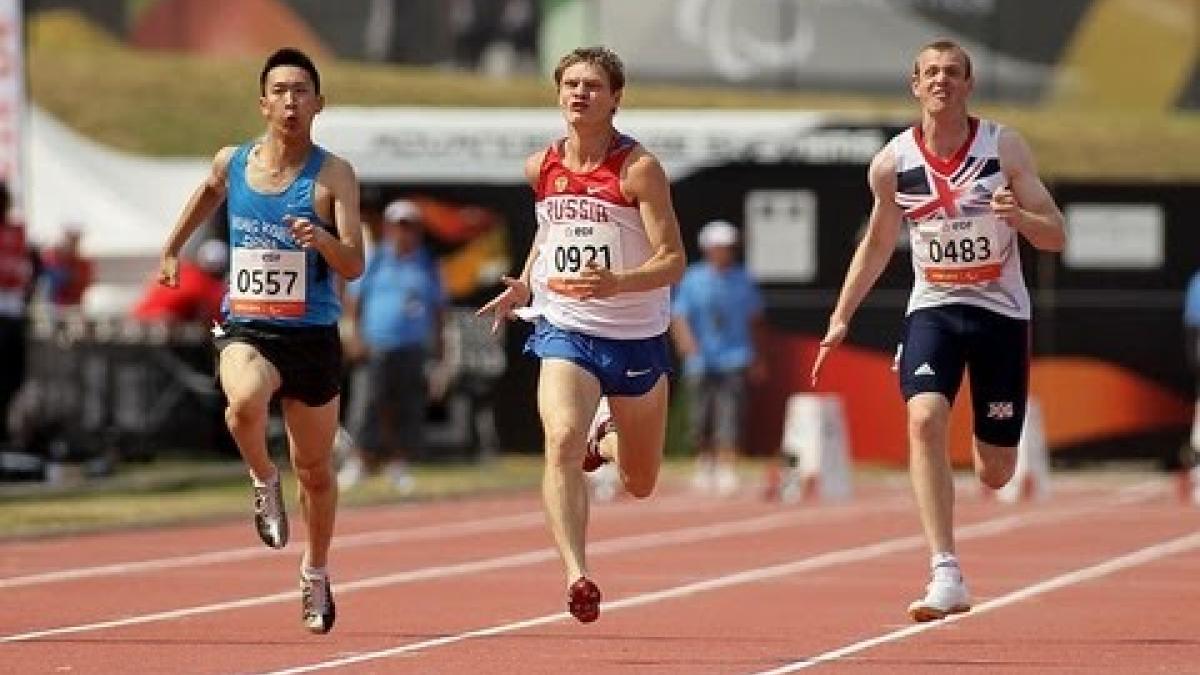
[{"xmin": 812, "ymin": 40, "xmax": 1066, "ymax": 621}]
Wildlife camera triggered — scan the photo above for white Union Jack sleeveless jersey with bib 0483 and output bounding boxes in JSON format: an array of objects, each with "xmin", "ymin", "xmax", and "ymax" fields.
[{"xmin": 889, "ymin": 118, "xmax": 1030, "ymax": 319}]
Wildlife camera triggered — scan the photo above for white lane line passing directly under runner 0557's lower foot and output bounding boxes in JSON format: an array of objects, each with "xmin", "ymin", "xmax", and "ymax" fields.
[{"xmin": 0, "ymin": 500, "xmax": 907, "ymax": 643}]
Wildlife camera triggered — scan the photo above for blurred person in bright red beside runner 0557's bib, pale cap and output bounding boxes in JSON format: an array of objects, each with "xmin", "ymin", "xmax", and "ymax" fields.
[{"xmin": 133, "ymin": 239, "xmax": 229, "ymax": 323}]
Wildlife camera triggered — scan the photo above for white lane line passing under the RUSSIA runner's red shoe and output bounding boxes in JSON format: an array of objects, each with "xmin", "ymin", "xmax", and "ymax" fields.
[{"xmin": 250, "ymin": 482, "xmax": 1161, "ymax": 675}]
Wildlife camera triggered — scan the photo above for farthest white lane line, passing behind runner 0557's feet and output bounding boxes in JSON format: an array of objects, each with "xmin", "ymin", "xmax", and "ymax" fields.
[{"xmin": 0, "ymin": 485, "xmax": 720, "ymax": 590}]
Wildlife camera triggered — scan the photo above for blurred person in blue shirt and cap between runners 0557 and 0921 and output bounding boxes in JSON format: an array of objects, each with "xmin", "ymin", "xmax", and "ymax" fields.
[{"xmin": 337, "ymin": 201, "xmax": 445, "ymax": 492}]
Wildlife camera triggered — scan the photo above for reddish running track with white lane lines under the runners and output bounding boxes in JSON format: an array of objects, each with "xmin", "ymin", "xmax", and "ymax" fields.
[{"xmin": 0, "ymin": 476, "xmax": 1200, "ymax": 674}]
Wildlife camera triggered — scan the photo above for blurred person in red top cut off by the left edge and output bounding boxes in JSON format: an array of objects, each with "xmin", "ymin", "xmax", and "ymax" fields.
[{"xmin": 0, "ymin": 181, "xmax": 37, "ymax": 442}]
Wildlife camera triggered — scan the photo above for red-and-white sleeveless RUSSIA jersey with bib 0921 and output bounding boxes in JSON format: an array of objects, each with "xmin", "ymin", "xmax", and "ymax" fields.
[{"xmin": 530, "ymin": 136, "xmax": 671, "ymax": 340}]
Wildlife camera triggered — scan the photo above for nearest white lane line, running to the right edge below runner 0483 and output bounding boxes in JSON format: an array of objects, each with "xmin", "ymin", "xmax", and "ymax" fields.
[{"xmin": 755, "ymin": 532, "xmax": 1200, "ymax": 675}]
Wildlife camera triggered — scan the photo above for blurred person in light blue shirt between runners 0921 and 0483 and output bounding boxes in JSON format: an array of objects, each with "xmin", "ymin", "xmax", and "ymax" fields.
[{"xmin": 671, "ymin": 221, "xmax": 763, "ymax": 495}]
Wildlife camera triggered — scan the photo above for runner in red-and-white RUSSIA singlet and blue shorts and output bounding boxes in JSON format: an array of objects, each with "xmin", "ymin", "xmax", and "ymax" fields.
[{"xmin": 479, "ymin": 48, "xmax": 685, "ymax": 623}]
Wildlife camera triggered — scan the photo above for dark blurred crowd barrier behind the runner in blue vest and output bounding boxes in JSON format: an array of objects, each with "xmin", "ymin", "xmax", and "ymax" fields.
[{"xmin": 0, "ymin": 309, "xmax": 505, "ymax": 483}]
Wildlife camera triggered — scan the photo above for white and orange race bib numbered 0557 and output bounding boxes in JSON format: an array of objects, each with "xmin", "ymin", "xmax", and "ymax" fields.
[{"xmin": 229, "ymin": 247, "xmax": 305, "ymax": 318}]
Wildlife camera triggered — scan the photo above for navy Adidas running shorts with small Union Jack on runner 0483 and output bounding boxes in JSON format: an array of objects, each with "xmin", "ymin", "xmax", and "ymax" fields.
[{"xmin": 896, "ymin": 305, "xmax": 1030, "ymax": 447}]
